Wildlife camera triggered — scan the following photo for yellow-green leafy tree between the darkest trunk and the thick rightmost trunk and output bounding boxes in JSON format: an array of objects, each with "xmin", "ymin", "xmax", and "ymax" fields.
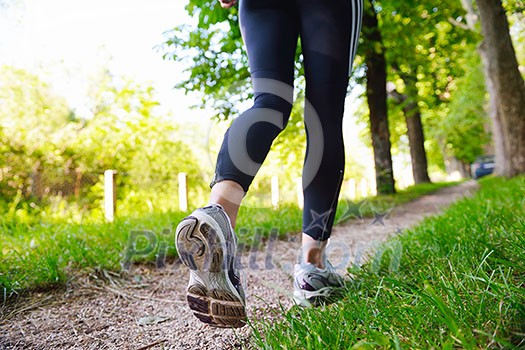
[{"xmin": 377, "ymin": 0, "xmax": 482, "ymax": 183}]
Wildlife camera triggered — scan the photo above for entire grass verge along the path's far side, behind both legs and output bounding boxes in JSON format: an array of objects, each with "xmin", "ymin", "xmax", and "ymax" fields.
[{"xmin": 0, "ymin": 180, "xmax": 449, "ymax": 298}]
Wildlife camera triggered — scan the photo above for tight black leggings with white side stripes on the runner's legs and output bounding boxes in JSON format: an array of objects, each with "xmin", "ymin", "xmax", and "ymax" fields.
[{"xmin": 213, "ymin": 0, "xmax": 363, "ymax": 241}]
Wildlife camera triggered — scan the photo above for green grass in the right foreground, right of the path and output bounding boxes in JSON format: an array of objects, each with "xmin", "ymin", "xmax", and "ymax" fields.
[{"xmin": 252, "ymin": 176, "xmax": 525, "ymax": 349}]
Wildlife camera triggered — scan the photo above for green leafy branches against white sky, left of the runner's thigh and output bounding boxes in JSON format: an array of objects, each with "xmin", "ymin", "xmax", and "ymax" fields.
[{"xmin": 160, "ymin": 0, "xmax": 248, "ymax": 119}]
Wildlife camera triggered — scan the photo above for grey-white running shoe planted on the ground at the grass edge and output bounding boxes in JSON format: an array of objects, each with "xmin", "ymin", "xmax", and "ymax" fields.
[{"xmin": 293, "ymin": 261, "xmax": 345, "ymax": 307}]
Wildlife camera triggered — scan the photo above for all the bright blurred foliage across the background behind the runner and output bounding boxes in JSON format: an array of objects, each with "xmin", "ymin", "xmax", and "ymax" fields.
[{"xmin": 0, "ymin": 0, "xmax": 525, "ymax": 221}]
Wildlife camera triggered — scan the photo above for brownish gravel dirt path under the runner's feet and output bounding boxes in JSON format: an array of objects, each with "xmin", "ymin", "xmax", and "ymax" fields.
[{"xmin": 0, "ymin": 181, "xmax": 477, "ymax": 350}]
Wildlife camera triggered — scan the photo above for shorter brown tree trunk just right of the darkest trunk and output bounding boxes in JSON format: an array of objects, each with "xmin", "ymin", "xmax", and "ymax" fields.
[{"xmin": 391, "ymin": 76, "xmax": 430, "ymax": 184}]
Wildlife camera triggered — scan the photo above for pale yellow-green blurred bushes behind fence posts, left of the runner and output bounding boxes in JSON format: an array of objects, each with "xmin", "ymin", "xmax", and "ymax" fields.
[{"xmin": 0, "ymin": 67, "xmax": 207, "ymax": 220}]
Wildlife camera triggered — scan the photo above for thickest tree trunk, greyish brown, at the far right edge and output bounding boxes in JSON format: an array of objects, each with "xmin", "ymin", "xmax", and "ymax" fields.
[{"xmin": 478, "ymin": 0, "xmax": 525, "ymax": 177}]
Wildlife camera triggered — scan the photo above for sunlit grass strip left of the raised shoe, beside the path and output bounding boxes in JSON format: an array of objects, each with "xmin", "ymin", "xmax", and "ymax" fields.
[{"xmin": 0, "ymin": 213, "xmax": 184, "ymax": 295}]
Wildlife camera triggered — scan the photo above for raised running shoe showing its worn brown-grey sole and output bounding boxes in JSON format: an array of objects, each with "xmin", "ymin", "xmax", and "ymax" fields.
[{"xmin": 175, "ymin": 204, "xmax": 246, "ymax": 328}]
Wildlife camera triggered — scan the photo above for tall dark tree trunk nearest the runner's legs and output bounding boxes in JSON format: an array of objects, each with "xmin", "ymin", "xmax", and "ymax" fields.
[{"xmin": 363, "ymin": 0, "xmax": 395, "ymax": 194}]
